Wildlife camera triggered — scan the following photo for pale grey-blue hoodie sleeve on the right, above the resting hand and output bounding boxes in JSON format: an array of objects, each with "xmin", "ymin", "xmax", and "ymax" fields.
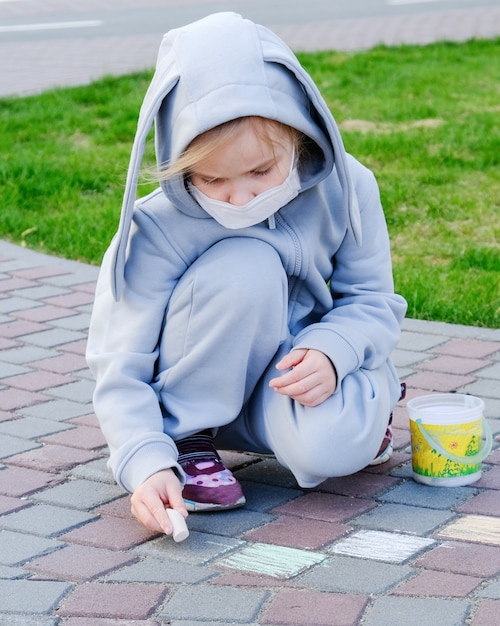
[{"xmin": 294, "ymin": 158, "xmax": 406, "ymax": 389}]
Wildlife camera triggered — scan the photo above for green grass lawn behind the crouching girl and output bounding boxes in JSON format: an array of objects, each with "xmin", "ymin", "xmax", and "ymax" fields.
[{"xmin": 0, "ymin": 39, "xmax": 500, "ymax": 327}]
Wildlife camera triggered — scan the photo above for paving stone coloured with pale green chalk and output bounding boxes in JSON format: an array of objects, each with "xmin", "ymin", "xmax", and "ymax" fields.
[{"xmin": 215, "ymin": 543, "xmax": 326, "ymax": 579}]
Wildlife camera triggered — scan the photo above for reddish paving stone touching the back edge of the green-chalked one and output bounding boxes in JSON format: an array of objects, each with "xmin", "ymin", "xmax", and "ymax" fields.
[{"xmin": 244, "ymin": 515, "xmax": 352, "ymax": 550}]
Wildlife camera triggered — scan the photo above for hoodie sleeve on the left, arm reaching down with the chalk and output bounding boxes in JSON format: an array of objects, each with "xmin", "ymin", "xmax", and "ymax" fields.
[{"xmin": 87, "ymin": 201, "xmax": 186, "ymax": 492}]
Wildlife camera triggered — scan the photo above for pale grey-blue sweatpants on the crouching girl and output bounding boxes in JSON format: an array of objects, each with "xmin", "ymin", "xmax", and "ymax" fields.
[{"xmin": 155, "ymin": 237, "xmax": 400, "ymax": 487}]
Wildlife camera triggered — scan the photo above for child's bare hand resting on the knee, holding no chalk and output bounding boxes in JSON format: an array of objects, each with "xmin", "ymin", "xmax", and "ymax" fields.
[{"xmin": 269, "ymin": 349, "xmax": 337, "ymax": 406}]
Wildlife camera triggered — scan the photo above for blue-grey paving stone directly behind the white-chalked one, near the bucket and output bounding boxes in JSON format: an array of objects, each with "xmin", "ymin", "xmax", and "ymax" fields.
[{"xmin": 351, "ymin": 503, "xmax": 455, "ymax": 535}]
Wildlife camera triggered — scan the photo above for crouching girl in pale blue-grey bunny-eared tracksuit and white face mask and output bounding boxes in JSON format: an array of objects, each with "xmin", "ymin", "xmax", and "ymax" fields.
[{"xmin": 87, "ymin": 13, "xmax": 406, "ymax": 533}]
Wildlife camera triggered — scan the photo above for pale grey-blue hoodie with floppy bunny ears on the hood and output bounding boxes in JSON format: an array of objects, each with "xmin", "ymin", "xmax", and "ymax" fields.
[{"xmin": 87, "ymin": 13, "xmax": 405, "ymax": 491}]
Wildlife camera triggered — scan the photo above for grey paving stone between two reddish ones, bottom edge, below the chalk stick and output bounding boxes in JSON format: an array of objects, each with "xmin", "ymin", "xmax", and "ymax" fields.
[{"xmin": 158, "ymin": 585, "xmax": 268, "ymax": 623}]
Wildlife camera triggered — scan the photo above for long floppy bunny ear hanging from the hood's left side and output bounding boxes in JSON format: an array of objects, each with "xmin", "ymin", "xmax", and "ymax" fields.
[{"xmin": 111, "ymin": 44, "xmax": 179, "ymax": 301}]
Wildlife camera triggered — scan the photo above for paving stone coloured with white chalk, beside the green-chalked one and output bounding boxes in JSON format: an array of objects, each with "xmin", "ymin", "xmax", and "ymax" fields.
[{"xmin": 330, "ymin": 530, "xmax": 435, "ymax": 563}]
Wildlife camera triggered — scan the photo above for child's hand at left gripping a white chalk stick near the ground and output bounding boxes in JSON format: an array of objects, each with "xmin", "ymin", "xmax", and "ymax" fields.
[{"xmin": 130, "ymin": 469, "xmax": 188, "ymax": 535}]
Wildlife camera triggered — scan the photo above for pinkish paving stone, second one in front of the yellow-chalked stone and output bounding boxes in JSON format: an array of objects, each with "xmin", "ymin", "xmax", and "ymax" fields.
[{"xmin": 392, "ymin": 570, "xmax": 483, "ymax": 598}]
